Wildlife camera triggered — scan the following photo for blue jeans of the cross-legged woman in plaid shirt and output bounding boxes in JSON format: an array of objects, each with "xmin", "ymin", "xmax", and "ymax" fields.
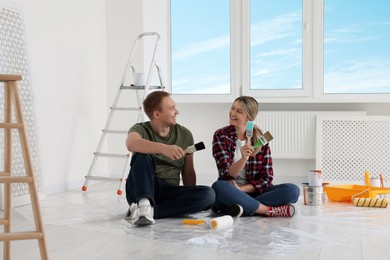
[{"xmin": 212, "ymin": 180, "xmax": 300, "ymax": 216}]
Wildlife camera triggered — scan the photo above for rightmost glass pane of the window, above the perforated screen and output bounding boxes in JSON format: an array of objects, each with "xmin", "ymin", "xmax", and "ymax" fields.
[{"xmin": 324, "ymin": 0, "xmax": 390, "ymax": 94}]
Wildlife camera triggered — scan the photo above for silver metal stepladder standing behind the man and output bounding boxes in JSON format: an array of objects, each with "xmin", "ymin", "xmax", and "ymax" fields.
[{"xmin": 82, "ymin": 32, "xmax": 165, "ymax": 195}]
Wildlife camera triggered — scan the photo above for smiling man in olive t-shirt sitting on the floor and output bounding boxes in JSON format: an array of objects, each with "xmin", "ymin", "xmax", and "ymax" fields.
[{"xmin": 126, "ymin": 91, "xmax": 215, "ymax": 226}]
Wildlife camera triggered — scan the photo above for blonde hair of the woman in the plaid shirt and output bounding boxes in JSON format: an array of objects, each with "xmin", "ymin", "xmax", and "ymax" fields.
[{"xmin": 234, "ymin": 96, "xmax": 263, "ymax": 156}]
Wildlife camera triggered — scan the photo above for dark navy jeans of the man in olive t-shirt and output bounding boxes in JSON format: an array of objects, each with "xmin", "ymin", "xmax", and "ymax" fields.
[{"xmin": 126, "ymin": 153, "xmax": 215, "ymax": 219}]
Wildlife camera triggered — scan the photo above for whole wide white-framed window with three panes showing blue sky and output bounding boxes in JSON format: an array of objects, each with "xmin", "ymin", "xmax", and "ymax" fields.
[{"xmin": 170, "ymin": 0, "xmax": 390, "ymax": 102}]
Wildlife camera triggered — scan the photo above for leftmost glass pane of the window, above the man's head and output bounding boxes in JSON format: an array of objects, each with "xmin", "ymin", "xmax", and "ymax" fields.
[{"xmin": 171, "ymin": 0, "xmax": 230, "ymax": 94}]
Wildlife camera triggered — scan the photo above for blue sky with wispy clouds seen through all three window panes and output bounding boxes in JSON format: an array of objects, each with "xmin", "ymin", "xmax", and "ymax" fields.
[{"xmin": 171, "ymin": 0, "xmax": 390, "ymax": 94}]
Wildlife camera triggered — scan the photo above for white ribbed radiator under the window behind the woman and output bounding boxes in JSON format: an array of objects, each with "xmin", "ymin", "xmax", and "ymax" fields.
[{"xmin": 255, "ymin": 111, "xmax": 366, "ymax": 159}]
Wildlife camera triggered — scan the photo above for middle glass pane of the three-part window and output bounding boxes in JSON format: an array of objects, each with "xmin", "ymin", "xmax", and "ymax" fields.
[{"xmin": 250, "ymin": 0, "xmax": 302, "ymax": 90}]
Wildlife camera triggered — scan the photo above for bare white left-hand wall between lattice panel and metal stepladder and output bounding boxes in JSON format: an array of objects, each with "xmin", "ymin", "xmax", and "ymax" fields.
[{"xmin": 14, "ymin": 0, "xmax": 107, "ymax": 193}]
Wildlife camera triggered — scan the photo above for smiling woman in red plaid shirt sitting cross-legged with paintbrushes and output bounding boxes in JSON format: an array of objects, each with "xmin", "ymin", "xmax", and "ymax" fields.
[{"xmin": 212, "ymin": 96, "xmax": 300, "ymax": 217}]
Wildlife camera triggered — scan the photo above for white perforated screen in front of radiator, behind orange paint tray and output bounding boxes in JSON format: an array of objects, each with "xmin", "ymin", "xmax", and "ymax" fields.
[{"xmin": 316, "ymin": 116, "xmax": 390, "ymax": 184}]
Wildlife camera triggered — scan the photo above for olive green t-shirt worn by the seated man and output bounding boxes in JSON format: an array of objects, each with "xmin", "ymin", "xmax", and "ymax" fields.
[{"xmin": 129, "ymin": 121, "xmax": 194, "ymax": 185}]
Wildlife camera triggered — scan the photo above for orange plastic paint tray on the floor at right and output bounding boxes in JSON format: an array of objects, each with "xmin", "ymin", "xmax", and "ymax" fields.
[{"xmin": 325, "ymin": 184, "xmax": 390, "ymax": 201}]
